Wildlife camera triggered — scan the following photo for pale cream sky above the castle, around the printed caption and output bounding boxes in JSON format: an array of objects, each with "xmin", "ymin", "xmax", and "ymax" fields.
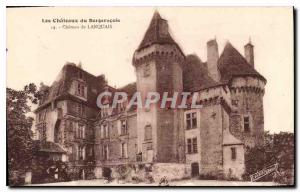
[{"xmin": 7, "ymin": 7, "xmax": 294, "ymax": 132}]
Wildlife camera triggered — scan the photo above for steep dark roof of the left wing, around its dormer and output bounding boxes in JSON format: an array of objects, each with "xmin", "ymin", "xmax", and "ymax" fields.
[{"xmin": 36, "ymin": 63, "xmax": 106, "ymax": 111}]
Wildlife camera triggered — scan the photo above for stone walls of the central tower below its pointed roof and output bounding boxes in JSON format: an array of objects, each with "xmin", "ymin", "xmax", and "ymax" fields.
[{"xmin": 134, "ymin": 45, "xmax": 184, "ymax": 162}]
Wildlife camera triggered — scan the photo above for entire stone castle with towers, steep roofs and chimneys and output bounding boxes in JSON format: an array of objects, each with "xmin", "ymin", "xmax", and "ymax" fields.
[{"xmin": 35, "ymin": 12, "xmax": 266, "ymax": 181}]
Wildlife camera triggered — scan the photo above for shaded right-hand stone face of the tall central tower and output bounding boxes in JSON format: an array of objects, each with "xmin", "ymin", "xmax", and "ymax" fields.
[{"xmin": 156, "ymin": 53, "xmax": 184, "ymax": 162}]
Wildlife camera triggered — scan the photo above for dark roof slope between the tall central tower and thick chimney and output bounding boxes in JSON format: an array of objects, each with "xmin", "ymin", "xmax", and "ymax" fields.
[{"xmin": 183, "ymin": 54, "xmax": 220, "ymax": 92}]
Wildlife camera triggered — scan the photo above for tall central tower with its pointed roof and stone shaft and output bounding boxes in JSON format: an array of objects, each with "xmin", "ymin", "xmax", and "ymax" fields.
[{"xmin": 133, "ymin": 12, "xmax": 185, "ymax": 162}]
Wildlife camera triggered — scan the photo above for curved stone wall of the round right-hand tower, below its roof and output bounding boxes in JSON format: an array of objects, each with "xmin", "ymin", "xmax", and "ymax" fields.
[{"xmin": 230, "ymin": 78, "xmax": 264, "ymax": 147}]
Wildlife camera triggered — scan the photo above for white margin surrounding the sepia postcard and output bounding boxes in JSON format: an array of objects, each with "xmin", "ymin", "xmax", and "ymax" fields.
[{"xmin": 0, "ymin": 0, "xmax": 300, "ymax": 191}]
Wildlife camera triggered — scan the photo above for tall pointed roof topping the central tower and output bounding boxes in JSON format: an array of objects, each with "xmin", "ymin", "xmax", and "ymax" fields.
[{"xmin": 138, "ymin": 11, "xmax": 176, "ymax": 50}]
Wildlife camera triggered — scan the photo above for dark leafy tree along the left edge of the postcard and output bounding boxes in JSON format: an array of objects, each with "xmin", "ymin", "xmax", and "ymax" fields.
[{"xmin": 6, "ymin": 83, "xmax": 40, "ymax": 185}]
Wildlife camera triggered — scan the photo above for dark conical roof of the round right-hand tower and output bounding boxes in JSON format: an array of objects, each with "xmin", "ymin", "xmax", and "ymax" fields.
[{"xmin": 218, "ymin": 42, "xmax": 266, "ymax": 82}]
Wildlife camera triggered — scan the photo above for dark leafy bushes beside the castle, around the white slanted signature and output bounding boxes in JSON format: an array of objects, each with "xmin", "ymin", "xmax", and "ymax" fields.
[{"xmin": 244, "ymin": 132, "xmax": 295, "ymax": 184}]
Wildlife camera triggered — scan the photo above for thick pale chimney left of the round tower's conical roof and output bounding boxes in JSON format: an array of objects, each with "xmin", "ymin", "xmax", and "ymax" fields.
[{"xmin": 207, "ymin": 39, "xmax": 220, "ymax": 82}]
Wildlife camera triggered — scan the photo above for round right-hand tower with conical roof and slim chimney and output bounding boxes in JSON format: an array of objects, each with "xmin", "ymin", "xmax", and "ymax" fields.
[{"xmin": 218, "ymin": 42, "xmax": 266, "ymax": 147}]
